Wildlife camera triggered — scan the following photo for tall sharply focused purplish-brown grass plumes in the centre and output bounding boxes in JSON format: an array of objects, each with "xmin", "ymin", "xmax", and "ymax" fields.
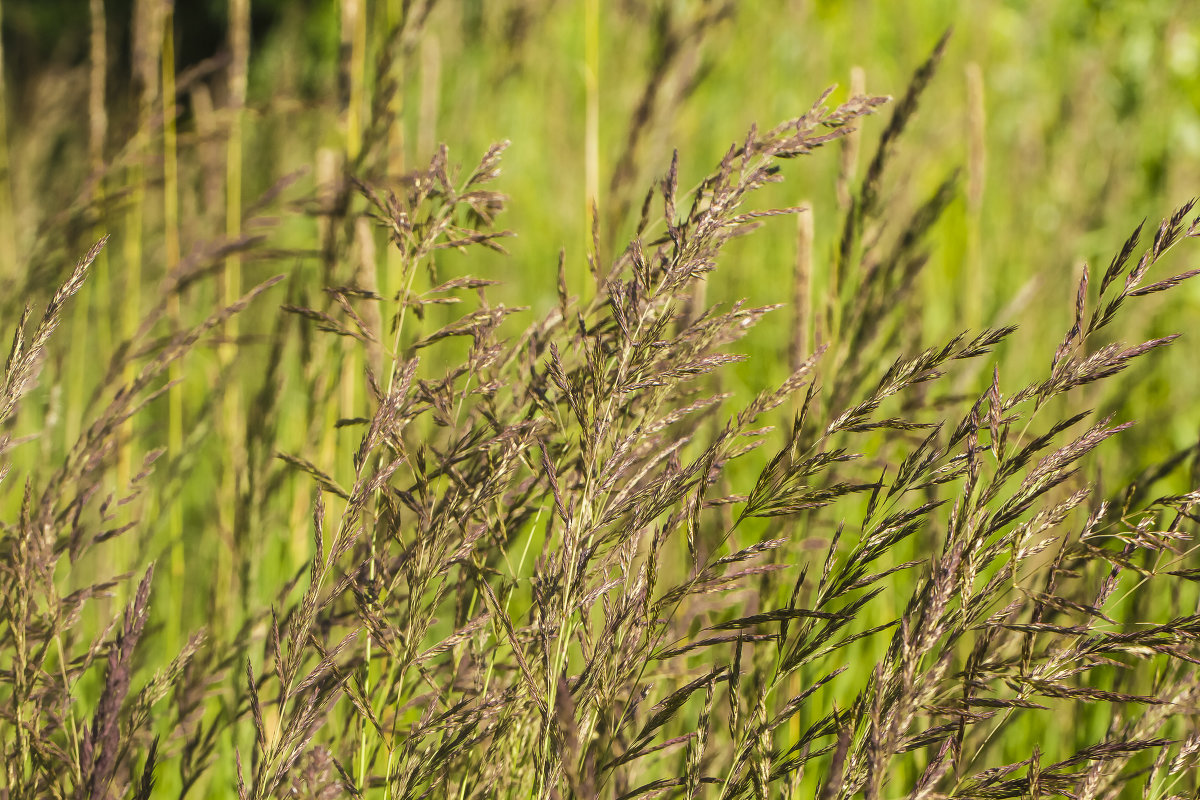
[{"xmin": 265, "ymin": 76, "xmax": 902, "ymax": 796}]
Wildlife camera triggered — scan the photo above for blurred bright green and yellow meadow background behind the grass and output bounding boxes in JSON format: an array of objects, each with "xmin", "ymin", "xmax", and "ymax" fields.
[{"xmin": 0, "ymin": 0, "xmax": 1200, "ymax": 662}]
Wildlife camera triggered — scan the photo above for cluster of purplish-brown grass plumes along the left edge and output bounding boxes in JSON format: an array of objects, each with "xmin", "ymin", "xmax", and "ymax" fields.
[{"xmin": 0, "ymin": 227, "xmax": 279, "ymax": 798}]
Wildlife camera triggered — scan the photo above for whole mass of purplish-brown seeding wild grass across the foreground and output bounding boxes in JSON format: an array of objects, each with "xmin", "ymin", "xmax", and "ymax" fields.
[{"xmin": 0, "ymin": 10, "xmax": 1200, "ymax": 800}]
